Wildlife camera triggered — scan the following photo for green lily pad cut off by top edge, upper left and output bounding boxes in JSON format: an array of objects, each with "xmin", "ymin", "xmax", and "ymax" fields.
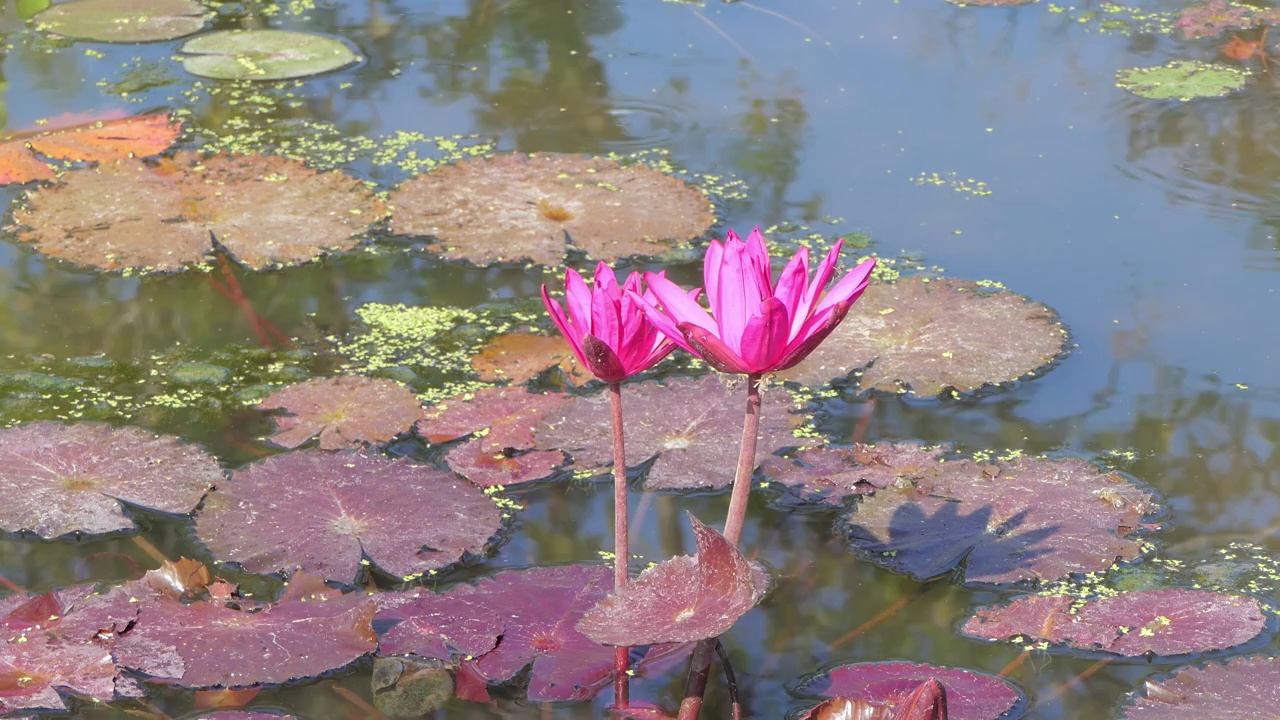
[{"xmin": 35, "ymin": 0, "xmax": 205, "ymax": 42}]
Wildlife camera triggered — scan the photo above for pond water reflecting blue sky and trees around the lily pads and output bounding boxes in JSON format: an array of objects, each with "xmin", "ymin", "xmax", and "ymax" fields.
[{"xmin": 0, "ymin": 0, "xmax": 1280, "ymax": 719}]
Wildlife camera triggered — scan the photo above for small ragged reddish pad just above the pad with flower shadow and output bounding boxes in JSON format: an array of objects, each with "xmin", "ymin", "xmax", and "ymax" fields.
[{"xmin": 760, "ymin": 442, "xmax": 946, "ymax": 505}]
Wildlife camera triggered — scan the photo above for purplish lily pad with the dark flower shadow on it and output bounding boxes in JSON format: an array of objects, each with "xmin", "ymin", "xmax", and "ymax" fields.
[{"xmin": 846, "ymin": 450, "xmax": 1157, "ymax": 583}]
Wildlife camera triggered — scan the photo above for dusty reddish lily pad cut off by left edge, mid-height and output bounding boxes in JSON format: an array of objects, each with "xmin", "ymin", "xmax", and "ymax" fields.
[{"xmin": 0, "ymin": 423, "xmax": 223, "ymax": 538}]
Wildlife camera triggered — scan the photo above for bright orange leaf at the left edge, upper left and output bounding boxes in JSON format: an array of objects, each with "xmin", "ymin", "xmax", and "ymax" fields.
[{"xmin": 0, "ymin": 112, "xmax": 181, "ymax": 184}]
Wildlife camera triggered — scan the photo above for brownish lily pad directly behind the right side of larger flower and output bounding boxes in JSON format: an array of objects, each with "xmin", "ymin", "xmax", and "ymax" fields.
[{"xmin": 778, "ymin": 277, "xmax": 1066, "ymax": 397}]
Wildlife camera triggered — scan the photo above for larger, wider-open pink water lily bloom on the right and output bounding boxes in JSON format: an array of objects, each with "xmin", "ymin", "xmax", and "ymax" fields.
[{"xmin": 644, "ymin": 228, "xmax": 876, "ymax": 374}]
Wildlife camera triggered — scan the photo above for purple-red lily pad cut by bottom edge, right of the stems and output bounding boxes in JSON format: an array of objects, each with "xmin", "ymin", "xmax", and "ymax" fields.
[{"xmin": 796, "ymin": 662, "xmax": 1023, "ymax": 720}]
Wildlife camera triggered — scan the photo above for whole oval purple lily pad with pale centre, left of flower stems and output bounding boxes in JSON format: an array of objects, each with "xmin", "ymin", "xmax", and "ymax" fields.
[{"xmin": 196, "ymin": 450, "xmax": 502, "ymax": 582}]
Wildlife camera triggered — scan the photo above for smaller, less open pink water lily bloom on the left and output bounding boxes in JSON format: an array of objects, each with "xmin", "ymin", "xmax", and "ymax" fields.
[{"xmin": 543, "ymin": 263, "xmax": 698, "ymax": 383}]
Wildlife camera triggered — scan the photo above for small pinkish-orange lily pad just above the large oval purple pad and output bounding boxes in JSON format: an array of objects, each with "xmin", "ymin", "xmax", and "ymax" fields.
[{"xmin": 257, "ymin": 375, "xmax": 422, "ymax": 450}]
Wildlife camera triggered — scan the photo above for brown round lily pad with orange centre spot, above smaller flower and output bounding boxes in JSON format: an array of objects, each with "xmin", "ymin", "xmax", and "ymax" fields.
[{"xmin": 390, "ymin": 152, "xmax": 716, "ymax": 265}]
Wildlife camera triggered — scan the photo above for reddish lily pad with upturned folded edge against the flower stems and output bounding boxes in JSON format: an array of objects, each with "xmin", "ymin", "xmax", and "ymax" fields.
[{"xmin": 577, "ymin": 514, "xmax": 769, "ymax": 647}]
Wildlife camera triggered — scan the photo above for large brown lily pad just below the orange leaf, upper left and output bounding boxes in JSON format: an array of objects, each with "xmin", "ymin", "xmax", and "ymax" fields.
[{"xmin": 14, "ymin": 151, "xmax": 384, "ymax": 272}]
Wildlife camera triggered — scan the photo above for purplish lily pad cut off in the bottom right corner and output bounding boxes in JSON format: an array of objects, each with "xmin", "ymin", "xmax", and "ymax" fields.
[{"xmin": 1124, "ymin": 656, "xmax": 1280, "ymax": 720}]
